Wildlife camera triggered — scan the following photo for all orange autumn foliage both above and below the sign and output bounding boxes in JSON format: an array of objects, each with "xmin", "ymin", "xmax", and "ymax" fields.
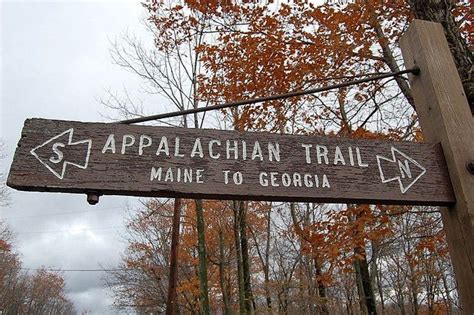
[{"xmin": 103, "ymin": 0, "xmax": 472, "ymax": 314}]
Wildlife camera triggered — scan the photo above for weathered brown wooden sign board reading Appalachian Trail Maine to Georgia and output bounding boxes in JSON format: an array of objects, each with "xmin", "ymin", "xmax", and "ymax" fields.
[{"xmin": 8, "ymin": 119, "xmax": 455, "ymax": 205}]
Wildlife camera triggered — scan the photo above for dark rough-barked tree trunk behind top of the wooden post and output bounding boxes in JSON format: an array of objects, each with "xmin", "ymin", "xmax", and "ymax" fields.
[{"xmin": 408, "ymin": 0, "xmax": 474, "ymax": 114}]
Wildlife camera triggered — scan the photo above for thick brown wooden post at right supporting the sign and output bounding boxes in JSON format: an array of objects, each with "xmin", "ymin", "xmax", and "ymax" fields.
[{"xmin": 400, "ymin": 20, "xmax": 474, "ymax": 314}]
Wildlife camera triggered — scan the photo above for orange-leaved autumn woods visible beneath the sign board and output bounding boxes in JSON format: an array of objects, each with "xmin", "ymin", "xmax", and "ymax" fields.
[{"xmin": 108, "ymin": 200, "xmax": 455, "ymax": 313}]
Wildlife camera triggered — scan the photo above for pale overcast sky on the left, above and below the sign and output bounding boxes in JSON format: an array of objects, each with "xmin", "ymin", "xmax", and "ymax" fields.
[{"xmin": 0, "ymin": 0, "xmax": 159, "ymax": 314}]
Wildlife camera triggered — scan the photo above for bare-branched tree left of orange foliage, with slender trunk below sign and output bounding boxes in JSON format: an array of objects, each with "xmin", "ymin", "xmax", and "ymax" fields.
[{"xmin": 103, "ymin": 1, "xmax": 220, "ymax": 314}]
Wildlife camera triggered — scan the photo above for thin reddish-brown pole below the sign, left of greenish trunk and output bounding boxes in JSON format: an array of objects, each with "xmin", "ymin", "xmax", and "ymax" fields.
[{"xmin": 166, "ymin": 198, "xmax": 181, "ymax": 315}]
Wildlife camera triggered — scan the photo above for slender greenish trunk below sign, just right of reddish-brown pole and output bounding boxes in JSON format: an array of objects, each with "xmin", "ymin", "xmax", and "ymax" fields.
[{"xmin": 194, "ymin": 199, "xmax": 211, "ymax": 315}]
